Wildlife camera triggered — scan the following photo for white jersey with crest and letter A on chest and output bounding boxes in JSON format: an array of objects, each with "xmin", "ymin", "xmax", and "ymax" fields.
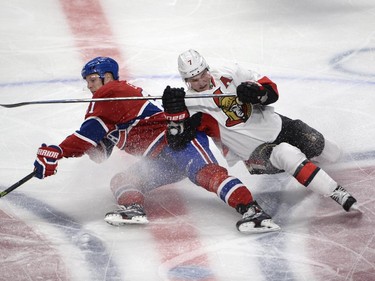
[{"xmin": 185, "ymin": 65, "xmax": 281, "ymax": 165}]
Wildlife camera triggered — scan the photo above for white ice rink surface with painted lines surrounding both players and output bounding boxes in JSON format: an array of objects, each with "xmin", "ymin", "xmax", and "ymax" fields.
[{"xmin": 0, "ymin": 0, "xmax": 375, "ymax": 281}]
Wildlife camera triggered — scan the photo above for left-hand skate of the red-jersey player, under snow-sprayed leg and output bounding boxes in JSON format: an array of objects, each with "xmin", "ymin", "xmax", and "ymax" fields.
[{"xmin": 104, "ymin": 204, "xmax": 148, "ymax": 226}]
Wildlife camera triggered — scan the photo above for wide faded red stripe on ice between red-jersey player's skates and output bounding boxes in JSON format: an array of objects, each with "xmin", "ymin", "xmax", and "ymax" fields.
[{"xmin": 146, "ymin": 185, "xmax": 216, "ymax": 281}]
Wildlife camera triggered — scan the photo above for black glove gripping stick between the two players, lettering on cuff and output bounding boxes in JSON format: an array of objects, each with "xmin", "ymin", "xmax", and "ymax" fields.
[{"xmin": 162, "ymin": 86, "xmax": 189, "ymax": 122}]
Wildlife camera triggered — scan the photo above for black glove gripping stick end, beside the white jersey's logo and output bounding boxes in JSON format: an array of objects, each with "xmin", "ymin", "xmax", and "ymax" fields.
[{"xmin": 237, "ymin": 81, "xmax": 267, "ymax": 104}]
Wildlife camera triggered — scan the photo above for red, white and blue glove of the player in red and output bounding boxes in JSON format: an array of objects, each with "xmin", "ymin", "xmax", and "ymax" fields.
[{"xmin": 34, "ymin": 143, "xmax": 63, "ymax": 179}]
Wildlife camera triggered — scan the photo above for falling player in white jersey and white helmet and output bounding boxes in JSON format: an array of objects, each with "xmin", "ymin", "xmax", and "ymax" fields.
[{"xmin": 163, "ymin": 49, "xmax": 358, "ymax": 211}]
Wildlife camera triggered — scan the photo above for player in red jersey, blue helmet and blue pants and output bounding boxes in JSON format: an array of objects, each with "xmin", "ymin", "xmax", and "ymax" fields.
[{"xmin": 34, "ymin": 57, "xmax": 280, "ymax": 233}]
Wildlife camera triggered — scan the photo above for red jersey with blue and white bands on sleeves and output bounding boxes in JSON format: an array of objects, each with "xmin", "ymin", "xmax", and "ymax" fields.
[{"xmin": 60, "ymin": 81, "xmax": 167, "ymax": 157}]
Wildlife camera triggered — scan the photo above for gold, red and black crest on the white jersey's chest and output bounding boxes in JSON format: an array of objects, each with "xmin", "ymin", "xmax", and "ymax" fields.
[{"xmin": 214, "ymin": 88, "xmax": 252, "ymax": 127}]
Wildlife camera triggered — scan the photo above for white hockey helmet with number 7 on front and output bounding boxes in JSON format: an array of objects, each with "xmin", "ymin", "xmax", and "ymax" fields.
[{"xmin": 177, "ymin": 49, "xmax": 209, "ymax": 81}]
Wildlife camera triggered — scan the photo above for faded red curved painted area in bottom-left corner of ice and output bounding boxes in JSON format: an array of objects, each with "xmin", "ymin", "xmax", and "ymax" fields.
[{"xmin": 0, "ymin": 210, "xmax": 70, "ymax": 281}]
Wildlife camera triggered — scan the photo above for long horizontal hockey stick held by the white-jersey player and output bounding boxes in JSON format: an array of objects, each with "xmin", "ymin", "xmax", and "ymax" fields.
[{"xmin": 0, "ymin": 94, "xmax": 236, "ymax": 108}]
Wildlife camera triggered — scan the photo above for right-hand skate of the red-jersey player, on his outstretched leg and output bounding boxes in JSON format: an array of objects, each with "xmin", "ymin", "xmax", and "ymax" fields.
[{"xmin": 236, "ymin": 201, "xmax": 281, "ymax": 234}]
